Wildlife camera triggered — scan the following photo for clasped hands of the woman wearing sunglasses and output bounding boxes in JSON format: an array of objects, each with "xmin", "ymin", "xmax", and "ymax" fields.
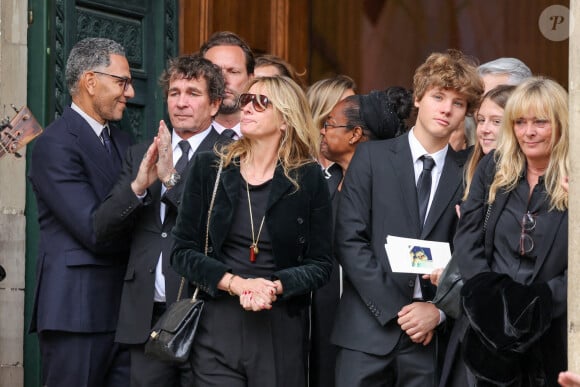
[{"xmin": 228, "ymin": 276, "xmax": 282, "ymax": 312}]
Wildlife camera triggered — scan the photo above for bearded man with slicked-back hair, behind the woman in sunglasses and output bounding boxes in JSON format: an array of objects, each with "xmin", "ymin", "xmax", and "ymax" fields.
[{"xmin": 200, "ymin": 31, "xmax": 254, "ymax": 139}]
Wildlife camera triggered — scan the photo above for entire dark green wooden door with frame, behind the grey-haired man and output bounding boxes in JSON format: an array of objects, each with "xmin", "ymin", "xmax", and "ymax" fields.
[{"xmin": 24, "ymin": 0, "xmax": 178, "ymax": 387}]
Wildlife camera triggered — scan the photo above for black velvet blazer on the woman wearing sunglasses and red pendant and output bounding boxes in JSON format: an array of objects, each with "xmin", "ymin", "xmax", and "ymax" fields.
[{"xmin": 171, "ymin": 152, "xmax": 332, "ymax": 303}]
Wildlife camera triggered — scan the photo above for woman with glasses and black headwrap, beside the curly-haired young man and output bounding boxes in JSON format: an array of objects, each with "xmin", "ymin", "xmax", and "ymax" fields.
[{"xmin": 310, "ymin": 87, "xmax": 413, "ymax": 387}]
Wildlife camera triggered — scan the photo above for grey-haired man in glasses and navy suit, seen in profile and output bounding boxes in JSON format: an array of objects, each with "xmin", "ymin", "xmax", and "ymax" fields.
[{"xmin": 29, "ymin": 38, "xmax": 135, "ymax": 387}]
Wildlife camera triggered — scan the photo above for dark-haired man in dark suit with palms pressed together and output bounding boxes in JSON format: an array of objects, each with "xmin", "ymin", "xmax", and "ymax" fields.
[{"xmin": 95, "ymin": 55, "xmax": 226, "ymax": 387}]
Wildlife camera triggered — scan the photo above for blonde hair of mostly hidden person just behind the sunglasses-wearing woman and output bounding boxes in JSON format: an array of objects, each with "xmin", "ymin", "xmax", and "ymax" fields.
[{"xmin": 306, "ymin": 75, "xmax": 356, "ymax": 130}]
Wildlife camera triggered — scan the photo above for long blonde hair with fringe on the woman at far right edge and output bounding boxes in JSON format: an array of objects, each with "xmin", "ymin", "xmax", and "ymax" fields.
[{"xmin": 489, "ymin": 77, "xmax": 569, "ymax": 211}]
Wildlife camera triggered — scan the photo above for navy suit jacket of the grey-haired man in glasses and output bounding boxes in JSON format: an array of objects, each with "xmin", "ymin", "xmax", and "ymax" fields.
[{"xmin": 28, "ymin": 107, "xmax": 130, "ymax": 332}]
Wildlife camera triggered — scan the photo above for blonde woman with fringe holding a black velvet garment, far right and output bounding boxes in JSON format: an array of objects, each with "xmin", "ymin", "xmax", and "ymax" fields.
[{"xmin": 448, "ymin": 77, "xmax": 569, "ymax": 386}]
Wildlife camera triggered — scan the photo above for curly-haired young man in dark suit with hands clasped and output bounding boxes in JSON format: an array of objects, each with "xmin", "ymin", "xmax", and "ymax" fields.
[{"xmin": 332, "ymin": 51, "xmax": 483, "ymax": 387}]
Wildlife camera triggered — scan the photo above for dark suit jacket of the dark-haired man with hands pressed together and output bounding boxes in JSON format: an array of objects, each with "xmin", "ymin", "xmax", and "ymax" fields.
[{"xmin": 95, "ymin": 128, "xmax": 220, "ymax": 344}]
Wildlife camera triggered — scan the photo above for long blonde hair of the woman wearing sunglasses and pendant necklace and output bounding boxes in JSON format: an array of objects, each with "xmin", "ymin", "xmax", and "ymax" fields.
[{"xmin": 218, "ymin": 76, "xmax": 319, "ymax": 190}]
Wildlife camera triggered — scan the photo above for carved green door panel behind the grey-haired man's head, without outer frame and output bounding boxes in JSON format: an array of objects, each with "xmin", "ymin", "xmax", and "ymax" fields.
[{"xmin": 53, "ymin": 0, "xmax": 177, "ymax": 141}]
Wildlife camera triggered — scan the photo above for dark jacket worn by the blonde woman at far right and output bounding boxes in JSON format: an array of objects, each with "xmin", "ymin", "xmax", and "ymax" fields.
[{"xmin": 454, "ymin": 152, "xmax": 568, "ymax": 383}]
